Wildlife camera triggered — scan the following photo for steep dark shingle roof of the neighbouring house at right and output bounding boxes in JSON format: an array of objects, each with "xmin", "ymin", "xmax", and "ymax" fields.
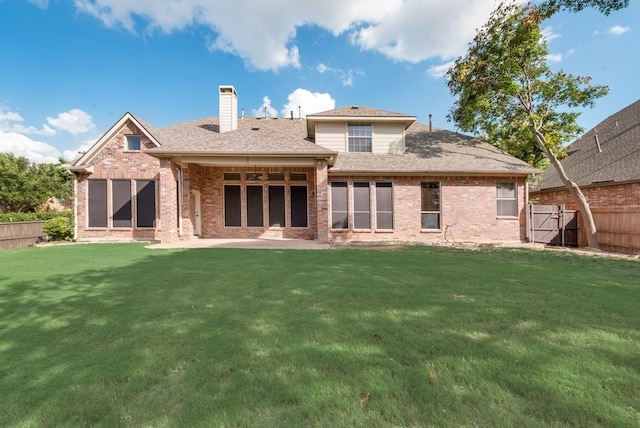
[{"xmin": 535, "ymin": 100, "xmax": 640, "ymax": 190}]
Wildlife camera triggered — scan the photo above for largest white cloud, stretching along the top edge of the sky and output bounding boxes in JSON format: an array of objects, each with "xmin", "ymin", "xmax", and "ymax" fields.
[{"xmin": 75, "ymin": 0, "xmax": 519, "ymax": 70}]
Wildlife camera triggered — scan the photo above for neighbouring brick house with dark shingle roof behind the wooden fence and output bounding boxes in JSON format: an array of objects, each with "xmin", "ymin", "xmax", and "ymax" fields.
[{"xmin": 531, "ymin": 100, "xmax": 640, "ymax": 209}]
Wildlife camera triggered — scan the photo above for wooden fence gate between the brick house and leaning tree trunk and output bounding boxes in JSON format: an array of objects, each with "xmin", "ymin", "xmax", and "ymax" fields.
[{"xmin": 527, "ymin": 205, "xmax": 578, "ymax": 247}]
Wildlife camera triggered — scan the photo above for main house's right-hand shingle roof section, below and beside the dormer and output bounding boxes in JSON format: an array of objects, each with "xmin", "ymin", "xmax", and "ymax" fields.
[{"xmin": 329, "ymin": 123, "xmax": 540, "ymax": 175}]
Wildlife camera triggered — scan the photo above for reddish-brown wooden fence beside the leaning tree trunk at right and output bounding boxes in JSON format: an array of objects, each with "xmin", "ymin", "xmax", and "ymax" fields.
[{"xmin": 580, "ymin": 207, "xmax": 640, "ymax": 254}]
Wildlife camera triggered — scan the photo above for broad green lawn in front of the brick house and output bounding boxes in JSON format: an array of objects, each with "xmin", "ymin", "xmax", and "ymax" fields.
[{"xmin": 0, "ymin": 244, "xmax": 640, "ymax": 427}]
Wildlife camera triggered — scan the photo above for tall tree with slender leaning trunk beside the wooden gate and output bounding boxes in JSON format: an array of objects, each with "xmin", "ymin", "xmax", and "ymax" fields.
[{"xmin": 447, "ymin": 4, "xmax": 608, "ymax": 249}]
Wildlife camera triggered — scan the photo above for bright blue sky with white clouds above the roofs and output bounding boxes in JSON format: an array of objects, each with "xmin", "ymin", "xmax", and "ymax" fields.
[{"xmin": 0, "ymin": 0, "xmax": 640, "ymax": 162}]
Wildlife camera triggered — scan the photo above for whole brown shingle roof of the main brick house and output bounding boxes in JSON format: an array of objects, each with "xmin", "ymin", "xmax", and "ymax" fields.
[{"xmin": 72, "ymin": 107, "xmax": 539, "ymax": 175}]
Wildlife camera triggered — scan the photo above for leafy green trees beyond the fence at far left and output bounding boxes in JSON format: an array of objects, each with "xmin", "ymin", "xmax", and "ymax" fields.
[{"xmin": 0, "ymin": 153, "xmax": 73, "ymax": 212}]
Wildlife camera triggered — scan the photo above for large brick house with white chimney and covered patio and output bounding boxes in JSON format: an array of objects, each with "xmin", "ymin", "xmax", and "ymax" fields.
[{"xmin": 70, "ymin": 86, "xmax": 538, "ymax": 243}]
